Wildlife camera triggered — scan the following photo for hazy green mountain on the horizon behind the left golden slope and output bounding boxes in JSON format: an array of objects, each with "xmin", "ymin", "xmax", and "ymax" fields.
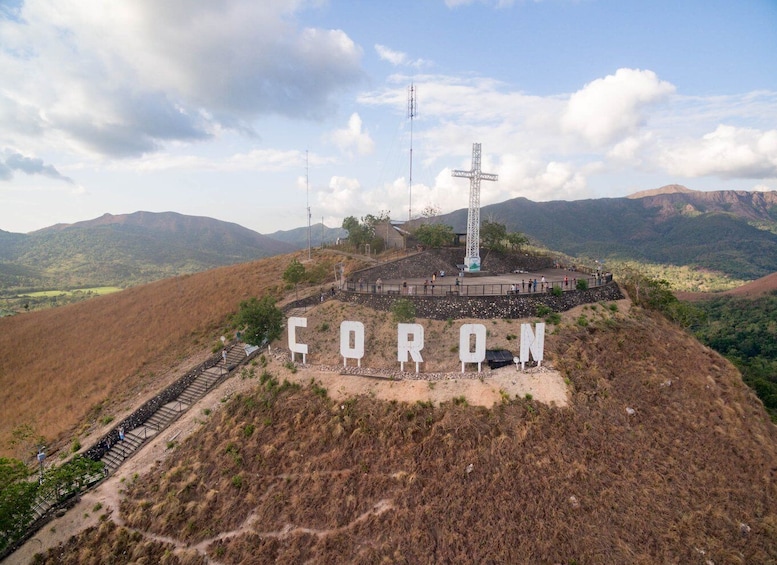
[{"xmin": 0, "ymin": 212, "xmax": 295, "ymax": 289}]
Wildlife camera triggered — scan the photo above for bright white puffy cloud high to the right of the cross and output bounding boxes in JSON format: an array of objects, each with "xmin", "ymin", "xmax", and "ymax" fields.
[{"xmin": 561, "ymin": 69, "xmax": 675, "ymax": 147}]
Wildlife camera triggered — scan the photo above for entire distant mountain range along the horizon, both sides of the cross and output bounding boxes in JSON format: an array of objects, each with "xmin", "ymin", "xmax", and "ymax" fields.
[{"xmin": 0, "ymin": 185, "xmax": 777, "ymax": 293}]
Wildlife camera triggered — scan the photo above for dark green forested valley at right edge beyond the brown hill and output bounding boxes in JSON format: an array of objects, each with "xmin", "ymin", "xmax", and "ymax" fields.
[{"xmin": 694, "ymin": 292, "xmax": 777, "ymax": 422}]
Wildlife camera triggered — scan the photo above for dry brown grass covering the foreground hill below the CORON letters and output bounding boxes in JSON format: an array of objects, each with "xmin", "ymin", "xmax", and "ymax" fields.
[{"xmin": 109, "ymin": 308, "xmax": 777, "ymax": 563}]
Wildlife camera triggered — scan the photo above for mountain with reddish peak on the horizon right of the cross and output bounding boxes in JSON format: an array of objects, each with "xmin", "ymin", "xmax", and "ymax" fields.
[{"xmin": 438, "ymin": 185, "xmax": 777, "ymax": 279}]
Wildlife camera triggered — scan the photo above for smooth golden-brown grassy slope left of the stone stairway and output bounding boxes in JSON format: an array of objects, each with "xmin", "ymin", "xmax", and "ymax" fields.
[{"xmin": 0, "ymin": 249, "xmax": 364, "ymax": 457}]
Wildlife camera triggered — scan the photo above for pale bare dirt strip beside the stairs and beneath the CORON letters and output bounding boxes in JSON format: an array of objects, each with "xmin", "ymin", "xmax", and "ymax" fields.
[{"xmin": 5, "ymin": 355, "xmax": 568, "ymax": 565}]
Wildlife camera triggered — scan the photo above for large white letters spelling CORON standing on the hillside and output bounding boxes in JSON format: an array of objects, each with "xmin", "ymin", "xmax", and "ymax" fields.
[{"xmin": 287, "ymin": 317, "xmax": 545, "ymax": 373}]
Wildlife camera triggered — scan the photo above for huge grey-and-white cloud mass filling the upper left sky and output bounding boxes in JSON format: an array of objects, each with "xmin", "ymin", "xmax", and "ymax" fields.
[{"xmin": 0, "ymin": 0, "xmax": 362, "ymax": 156}]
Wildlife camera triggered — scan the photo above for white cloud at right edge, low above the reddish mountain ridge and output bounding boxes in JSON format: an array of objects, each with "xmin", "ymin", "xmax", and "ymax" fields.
[{"xmin": 660, "ymin": 125, "xmax": 777, "ymax": 179}]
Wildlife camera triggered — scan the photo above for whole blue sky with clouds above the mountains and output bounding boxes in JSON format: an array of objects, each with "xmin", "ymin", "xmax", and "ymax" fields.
[{"xmin": 0, "ymin": 0, "xmax": 777, "ymax": 234}]
